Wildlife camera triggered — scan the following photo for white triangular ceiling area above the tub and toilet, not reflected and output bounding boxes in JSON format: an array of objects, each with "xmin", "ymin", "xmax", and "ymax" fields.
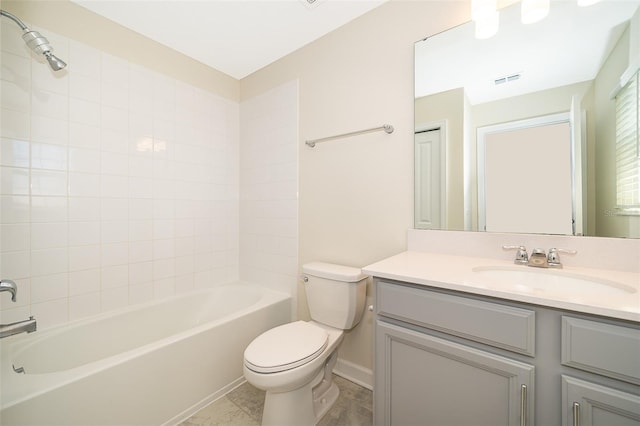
[{"xmin": 71, "ymin": 0, "xmax": 387, "ymax": 79}]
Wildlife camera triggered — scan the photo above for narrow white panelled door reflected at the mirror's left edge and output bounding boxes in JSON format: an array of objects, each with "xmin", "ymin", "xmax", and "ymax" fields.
[{"xmin": 414, "ymin": 125, "xmax": 446, "ymax": 229}]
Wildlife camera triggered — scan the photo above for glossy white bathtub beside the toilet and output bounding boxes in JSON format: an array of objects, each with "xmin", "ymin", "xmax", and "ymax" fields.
[{"xmin": 0, "ymin": 283, "xmax": 291, "ymax": 426}]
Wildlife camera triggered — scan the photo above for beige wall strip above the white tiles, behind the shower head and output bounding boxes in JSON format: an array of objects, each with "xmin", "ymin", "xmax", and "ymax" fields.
[{"xmin": 2, "ymin": 0, "xmax": 240, "ymax": 101}]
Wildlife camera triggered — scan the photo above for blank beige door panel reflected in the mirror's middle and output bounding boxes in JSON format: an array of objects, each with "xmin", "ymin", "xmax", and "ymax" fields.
[{"xmin": 478, "ymin": 114, "xmax": 574, "ymax": 235}]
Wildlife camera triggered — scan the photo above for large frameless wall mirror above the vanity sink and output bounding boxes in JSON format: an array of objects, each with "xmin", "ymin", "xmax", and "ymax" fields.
[{"xmin": 414, "ymin": 0, "xmax": 640, "ymax": 238}]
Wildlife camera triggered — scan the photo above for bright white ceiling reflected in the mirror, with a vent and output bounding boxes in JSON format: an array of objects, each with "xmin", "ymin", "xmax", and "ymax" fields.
[{"xmin": 415, "ymin": 0, "xmax": 640, "ymax": 105}]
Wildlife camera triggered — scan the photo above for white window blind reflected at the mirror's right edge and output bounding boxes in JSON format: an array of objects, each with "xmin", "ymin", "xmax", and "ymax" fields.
[{"xmin": 616, "ymin": 72, "xmax": 640, "ymax": 214}]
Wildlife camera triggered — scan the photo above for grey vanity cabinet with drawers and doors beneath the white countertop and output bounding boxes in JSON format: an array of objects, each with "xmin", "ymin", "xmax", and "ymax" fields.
[{"xmin": 374, "ymin": 278, "xmax": 640, "ymax": 426}]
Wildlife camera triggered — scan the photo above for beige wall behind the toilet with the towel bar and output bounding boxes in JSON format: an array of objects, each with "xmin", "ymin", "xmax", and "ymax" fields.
[{"xmin": 241, "ymin": 0, "xmax": 470, "ymax": 369}]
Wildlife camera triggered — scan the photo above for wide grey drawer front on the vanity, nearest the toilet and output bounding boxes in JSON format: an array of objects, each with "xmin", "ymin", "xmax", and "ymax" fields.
[{"xmin": 376, "ymin": 281, "xmax": 535, "ymax": 356}]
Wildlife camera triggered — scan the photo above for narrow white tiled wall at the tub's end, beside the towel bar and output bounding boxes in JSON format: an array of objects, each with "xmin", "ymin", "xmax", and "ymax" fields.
[{"xmin": 240, "ymin": 80, "xmax": 298, "ymax": 298}]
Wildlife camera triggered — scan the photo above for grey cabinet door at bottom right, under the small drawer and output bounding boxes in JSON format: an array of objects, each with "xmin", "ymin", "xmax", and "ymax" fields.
[{"xmin": 562, "ymin": 376, "xmax": 640, "ymax": 426}]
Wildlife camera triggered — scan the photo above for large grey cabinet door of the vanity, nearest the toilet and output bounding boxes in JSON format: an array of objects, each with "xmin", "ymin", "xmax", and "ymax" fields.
[{"xmin": 374, "ymin": 321, "xmax": 534, "ymax": 426}]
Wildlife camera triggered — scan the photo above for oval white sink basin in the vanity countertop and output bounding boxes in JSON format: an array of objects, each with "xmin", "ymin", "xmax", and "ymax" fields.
[{"xmin": 472, "ymin": 265, "xmax": 637, "ymax": 295}]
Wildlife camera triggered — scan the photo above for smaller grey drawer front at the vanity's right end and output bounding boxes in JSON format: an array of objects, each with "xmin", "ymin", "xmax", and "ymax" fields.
[{"xmin": 562, "ymin": 316, "xmax": 640, "ymax": 384}]
